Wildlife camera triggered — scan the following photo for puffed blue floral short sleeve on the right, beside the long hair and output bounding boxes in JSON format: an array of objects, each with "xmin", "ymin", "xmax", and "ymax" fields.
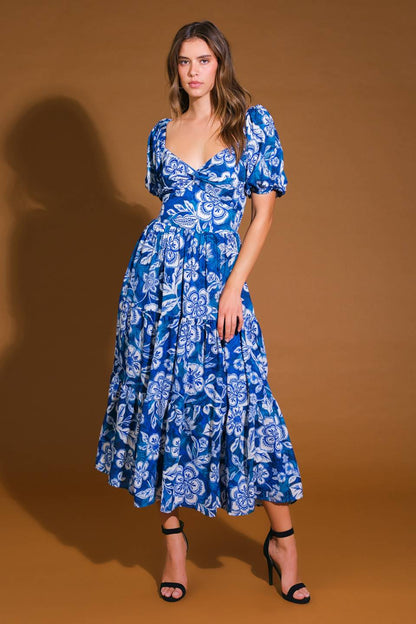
[{"xmin": 244, "ymin": 104, "xmax": 287, "ymax": 197}]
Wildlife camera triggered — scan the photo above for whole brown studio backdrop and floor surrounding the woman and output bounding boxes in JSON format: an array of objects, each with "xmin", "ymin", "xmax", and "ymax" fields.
[{"xmin": 0, "ymin": 0, "xmax": 415, "ymax": 624}]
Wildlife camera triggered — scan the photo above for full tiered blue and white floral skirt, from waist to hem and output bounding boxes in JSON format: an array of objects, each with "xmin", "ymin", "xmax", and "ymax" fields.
[{"xmin": 95, "ymin": 219, "xmax": 303, "ymax": 517}]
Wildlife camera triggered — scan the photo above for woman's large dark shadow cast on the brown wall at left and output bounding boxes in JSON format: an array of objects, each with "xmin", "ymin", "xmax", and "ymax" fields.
[{"xmin": 0, "ymin": 97, "xmax": 156, "ymax": 552}]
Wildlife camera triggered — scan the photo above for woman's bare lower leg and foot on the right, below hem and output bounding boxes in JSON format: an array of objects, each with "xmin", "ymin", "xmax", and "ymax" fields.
[{"xmin": 263, "ymin": 501, "xmax": 309, "ymax": 599}]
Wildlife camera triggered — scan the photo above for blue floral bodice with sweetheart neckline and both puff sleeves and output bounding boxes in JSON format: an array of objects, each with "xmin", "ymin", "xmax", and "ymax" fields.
[{"xmin": 145, "ymin": 104, "xmax": 287, "ymax": 232}]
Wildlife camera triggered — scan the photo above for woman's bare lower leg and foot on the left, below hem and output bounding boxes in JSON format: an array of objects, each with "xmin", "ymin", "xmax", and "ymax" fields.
[{"xmin": 159, "ymin": 502, "xmax": 188, "ymax": 598}]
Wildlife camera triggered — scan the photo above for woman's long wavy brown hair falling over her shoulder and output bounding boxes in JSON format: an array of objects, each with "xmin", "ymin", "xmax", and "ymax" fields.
[{"xmin": 166, "ymin": 20, "xmax": 251, "ymax": 162}]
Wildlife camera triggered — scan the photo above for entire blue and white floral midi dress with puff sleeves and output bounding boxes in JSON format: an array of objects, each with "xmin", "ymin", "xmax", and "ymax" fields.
[{"xmin": 95, "ymin": 104, "xmax": 303, "ymax": 517}]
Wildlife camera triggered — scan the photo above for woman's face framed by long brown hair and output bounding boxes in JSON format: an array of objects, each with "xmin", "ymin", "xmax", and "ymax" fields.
[{"xmin": 178, "ymin": 37, "xmax": 218, "ymax": 98}]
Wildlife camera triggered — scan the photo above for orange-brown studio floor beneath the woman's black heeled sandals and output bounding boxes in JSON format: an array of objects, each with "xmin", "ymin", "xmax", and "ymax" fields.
[{"xmin": 0, "ymin": 480, "xmax": 414, "ymax": 624}]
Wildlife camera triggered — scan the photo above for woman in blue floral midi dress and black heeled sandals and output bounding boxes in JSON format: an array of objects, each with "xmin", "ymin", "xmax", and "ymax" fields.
[{"xmin": 96, "ymin": 21, "xmax": 310, "ymax": 603}]
